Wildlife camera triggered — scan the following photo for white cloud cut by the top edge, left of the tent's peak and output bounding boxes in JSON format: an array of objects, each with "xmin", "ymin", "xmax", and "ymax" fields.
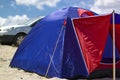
[{"xmin": 15, "ymin": 0, "xmax": 61, "ymax": 9}]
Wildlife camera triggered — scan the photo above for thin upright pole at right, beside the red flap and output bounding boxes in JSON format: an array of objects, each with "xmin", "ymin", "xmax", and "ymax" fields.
[{"xmin": 112, "ymin": 11, "xmax": 116, "ymax": 80}]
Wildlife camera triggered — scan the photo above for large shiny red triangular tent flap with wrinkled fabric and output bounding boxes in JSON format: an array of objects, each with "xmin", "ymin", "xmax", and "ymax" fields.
[{"xmin": 73, "ymin": 15, "xmax": 111, "ymax": 73}]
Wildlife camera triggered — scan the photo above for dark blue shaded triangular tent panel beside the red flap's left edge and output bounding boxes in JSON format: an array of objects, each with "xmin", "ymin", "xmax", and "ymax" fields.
[{"xmin": 62, "ymin": 18, "xmax": 88, "ymax": 77}]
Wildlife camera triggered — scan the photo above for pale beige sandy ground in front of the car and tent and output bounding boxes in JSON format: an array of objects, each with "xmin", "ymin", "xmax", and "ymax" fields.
[{"xmin": 0, "ymin": 44, "xmax": 120, "ymax": 80}]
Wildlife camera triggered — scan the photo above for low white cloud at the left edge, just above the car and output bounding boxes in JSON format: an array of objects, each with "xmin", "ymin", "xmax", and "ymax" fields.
[{"xmin": 0, "ymin": 14, "xmax": 29, "ymax": 26}]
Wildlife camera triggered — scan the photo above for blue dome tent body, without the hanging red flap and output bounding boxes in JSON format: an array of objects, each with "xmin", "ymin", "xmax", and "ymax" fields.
[{"xmin": 10, "ymin": 7, "xmax": 119, "ymax": 78}]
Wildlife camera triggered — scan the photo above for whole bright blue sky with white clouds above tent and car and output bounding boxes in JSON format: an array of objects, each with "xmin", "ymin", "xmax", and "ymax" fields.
[{"xmin": 0, "ymin": 0, "xmax": 120, "ymax": 26}]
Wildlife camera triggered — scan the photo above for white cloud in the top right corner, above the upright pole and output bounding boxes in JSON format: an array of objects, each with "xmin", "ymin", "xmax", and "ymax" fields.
[{"xmin": 90, "ymin": 0, "xmax": 120, "ymax": 14}]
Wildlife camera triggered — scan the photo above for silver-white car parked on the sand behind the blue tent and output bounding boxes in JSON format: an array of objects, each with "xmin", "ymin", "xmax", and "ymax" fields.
[{"xmin": 0, "ymin": 17, "xmax": 41, "ymax": 46}]
